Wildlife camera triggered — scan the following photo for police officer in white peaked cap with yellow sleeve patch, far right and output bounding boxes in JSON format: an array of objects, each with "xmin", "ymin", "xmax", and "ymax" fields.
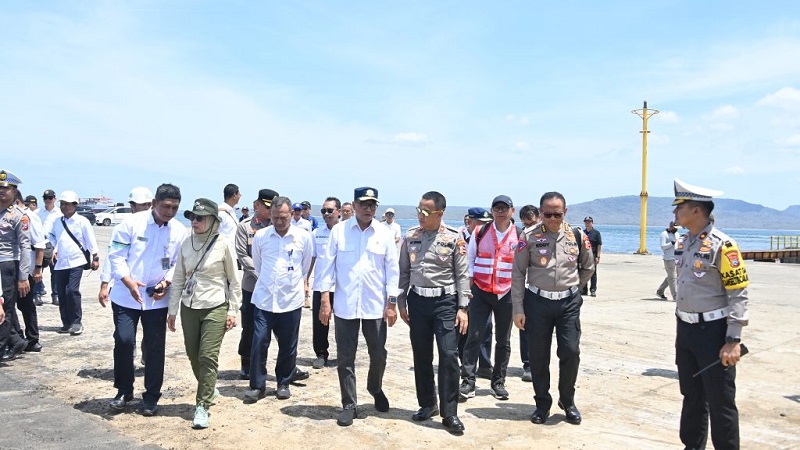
[{"xmin": 672, "ymin": 180, "xmax": 749, "ymax": 449}]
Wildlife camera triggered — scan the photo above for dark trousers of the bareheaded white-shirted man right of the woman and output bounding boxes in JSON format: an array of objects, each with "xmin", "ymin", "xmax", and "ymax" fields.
[{"xmin": 250, "ymin": 307, "xmax": 303, "ymax": 389}]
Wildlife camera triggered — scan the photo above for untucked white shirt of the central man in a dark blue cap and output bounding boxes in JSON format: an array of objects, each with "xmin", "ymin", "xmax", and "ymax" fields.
[{"xmin": 320, "ymin": 217, "xmax": 400, "ymax": 319}]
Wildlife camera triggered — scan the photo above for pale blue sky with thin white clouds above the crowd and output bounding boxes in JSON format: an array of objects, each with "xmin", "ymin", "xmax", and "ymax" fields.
[{"xmin": 0, "ymin": 0, "xmax": 800, "ymax": 209}]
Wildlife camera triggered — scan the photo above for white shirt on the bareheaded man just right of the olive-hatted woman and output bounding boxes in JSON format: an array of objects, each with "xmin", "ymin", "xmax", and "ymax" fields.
[{"xmin": 252, "ymin": 225, "xmax": 314, "ymax": 313}]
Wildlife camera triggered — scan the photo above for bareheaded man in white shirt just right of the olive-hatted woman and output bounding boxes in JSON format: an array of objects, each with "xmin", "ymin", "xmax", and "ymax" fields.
[{"xmin": 244, "ymin": 196, "xmax": 314, "ymax": 401}]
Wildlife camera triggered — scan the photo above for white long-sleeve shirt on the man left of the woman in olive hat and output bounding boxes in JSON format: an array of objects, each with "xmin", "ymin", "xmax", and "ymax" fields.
[{"xmin": 108, "ymin": 210, "xmax": 187, "ymax": 310}]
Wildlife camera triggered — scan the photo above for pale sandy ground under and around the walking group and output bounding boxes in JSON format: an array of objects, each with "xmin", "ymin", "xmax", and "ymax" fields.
[{"xmin": 0, "ymin": 227, "xmax": 800, "ymax": 449}]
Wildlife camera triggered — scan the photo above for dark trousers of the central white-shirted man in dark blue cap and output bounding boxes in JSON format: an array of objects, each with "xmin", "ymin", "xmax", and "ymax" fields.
[{"xmin": 333, "ymin": 315, "xmax": 388, "ymax": 409}]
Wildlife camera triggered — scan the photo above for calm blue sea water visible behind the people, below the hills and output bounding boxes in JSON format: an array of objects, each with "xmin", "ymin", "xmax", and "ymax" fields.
[{"xmin": 397, "ymin": 219, "xmax": 800, "ymax": 255}]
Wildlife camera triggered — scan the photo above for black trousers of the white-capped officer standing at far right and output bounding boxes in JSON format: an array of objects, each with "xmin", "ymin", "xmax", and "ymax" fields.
[{"xmin": 675, "ymin": 319, "xmax": 739, "ymax": 450}]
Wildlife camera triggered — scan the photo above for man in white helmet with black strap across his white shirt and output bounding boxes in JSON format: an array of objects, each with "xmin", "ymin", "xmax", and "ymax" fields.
[{"xmin": 48, "ymin": 191, "xmax": 100, "ymax": 336}]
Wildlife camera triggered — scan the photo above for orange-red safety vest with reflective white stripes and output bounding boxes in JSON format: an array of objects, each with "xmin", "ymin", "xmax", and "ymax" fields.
[{"xmin": 472, "ymin": 224, "xmax": 519, "ymax": 297}]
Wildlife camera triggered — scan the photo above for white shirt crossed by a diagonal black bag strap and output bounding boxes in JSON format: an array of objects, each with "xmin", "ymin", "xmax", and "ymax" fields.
[{"xmin": 48, "ymin": 213, "xmax": 97, "ymax": 270}]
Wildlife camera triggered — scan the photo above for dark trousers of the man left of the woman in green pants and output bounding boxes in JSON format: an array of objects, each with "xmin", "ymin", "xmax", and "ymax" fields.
[{"xmin": 111, "ymin": 302, "xmax": 167, "ymax": 403}]
